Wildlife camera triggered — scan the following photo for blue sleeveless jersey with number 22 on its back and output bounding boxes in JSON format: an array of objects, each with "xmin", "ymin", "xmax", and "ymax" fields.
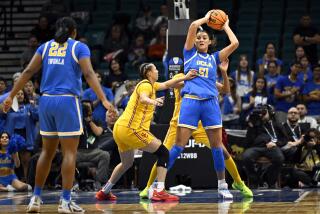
[{"xmin": 36, "ymin": 38, "xmax": 90, "ymax": 96}]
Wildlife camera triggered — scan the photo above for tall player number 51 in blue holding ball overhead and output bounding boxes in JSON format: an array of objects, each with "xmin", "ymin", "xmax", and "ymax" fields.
[{"xmin": 164, "ymin": 11, "xmax": 239, "ymax": 199}]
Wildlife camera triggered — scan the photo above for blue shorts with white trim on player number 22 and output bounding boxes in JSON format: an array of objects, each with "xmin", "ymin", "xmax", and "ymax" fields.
[{"xmin": 39, "ymin": 94, "xmax": 83, "ymax": 137}]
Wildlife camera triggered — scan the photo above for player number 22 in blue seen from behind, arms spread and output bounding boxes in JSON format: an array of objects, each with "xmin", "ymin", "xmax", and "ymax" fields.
[{"xmin": 4, "ymin": 17, "xmax": 114, "ymax": 213}]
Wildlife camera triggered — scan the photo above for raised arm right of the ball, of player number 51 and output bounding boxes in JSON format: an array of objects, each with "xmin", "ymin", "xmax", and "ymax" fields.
[{"xmin": 219, "ymin": 19, "xmax": 239, "ymax": 62}]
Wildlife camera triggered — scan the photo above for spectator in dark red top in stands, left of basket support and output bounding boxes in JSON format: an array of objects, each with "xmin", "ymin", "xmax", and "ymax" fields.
[{"xmin": 147, "ymin": 25, "xmax": 167, "ymax": 61}]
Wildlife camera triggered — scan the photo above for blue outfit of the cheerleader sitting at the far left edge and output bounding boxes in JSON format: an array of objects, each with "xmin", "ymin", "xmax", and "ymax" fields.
[{"xmin": 0, "ymin": 150, "xmax": 18, "ymax": 187}]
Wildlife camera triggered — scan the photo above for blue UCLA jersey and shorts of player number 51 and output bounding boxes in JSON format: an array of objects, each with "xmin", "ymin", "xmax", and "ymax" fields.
[{"xmin": 178, "ymin": 47, "xmax": 222, "ymax": 129}]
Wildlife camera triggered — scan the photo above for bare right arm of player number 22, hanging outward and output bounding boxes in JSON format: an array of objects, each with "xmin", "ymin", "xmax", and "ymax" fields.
[{"xmin": 79, "ymin": 57, "xmax": 114, "ymax": 111}]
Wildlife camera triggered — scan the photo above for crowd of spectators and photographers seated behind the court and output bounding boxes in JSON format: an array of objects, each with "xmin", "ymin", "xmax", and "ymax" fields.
[{"xmin": 0, "ymin": 0, "xmax": 320, "ymax": 189}]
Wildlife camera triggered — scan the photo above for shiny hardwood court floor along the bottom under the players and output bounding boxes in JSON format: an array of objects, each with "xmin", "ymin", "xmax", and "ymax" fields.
[{"xmin": 0, "ymin": 189, "xmax": 320, "ymax": 214}]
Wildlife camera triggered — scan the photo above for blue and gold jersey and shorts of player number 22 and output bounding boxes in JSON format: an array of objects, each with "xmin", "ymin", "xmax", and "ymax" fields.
[{"xmin": 36, "ymin": 38, "xmax": 90, "ymax": 137}]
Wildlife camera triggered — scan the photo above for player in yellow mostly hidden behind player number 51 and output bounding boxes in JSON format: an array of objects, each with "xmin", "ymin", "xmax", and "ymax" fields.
[{"xmin": 139, "ymin": 59, "xmax": 252, "ymax": 198}]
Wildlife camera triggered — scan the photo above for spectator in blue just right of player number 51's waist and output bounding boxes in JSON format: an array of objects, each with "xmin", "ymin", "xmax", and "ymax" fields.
[{"xmin": 221, "ymin": 78, "xmax": 241, "ymax": 129}]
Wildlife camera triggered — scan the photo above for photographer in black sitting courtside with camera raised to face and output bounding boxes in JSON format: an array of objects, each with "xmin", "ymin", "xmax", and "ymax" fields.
[{"xmin": 242, "ymin": 105, "xmax": 285, "ymax": 188}]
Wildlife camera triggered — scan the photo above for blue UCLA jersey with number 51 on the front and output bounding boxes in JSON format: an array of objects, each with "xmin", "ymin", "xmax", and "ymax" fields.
[{"xmin": 181, "ymin": 47, "xmax": 220, "ymax": 99}]
